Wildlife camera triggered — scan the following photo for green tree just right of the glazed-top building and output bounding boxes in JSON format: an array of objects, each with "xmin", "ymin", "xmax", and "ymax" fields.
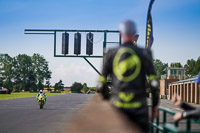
[{"xmin": 184, "ymin": 59, "xmax": 197, "ymax": 78}]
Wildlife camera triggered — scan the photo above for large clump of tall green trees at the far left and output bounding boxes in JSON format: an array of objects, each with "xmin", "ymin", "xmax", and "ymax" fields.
[{"xmin": 0, "ymin": 54, "xmax": 52, "ymax": 92}]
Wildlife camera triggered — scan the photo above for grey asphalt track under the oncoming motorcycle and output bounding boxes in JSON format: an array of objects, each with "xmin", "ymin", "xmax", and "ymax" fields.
[{"xmin": 0, "ymin": 94, "xmax": 93, "ymax": 133}]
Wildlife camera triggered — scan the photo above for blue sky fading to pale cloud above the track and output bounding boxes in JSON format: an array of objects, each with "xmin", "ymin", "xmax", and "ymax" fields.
[{"xmin": 0, "ymin": 0, "xmax": 200, "ymax": 86}]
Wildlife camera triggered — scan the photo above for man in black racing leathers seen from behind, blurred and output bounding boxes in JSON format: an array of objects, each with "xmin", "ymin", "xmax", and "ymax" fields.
[{"xmin": 97, "ymin": 20, "xmax": 158, "ymax": 133}]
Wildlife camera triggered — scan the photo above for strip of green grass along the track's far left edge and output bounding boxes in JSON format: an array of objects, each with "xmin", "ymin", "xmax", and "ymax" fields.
[{"xmin": 0, "ymin": 92, "xmax": 62, "ymax": 100}]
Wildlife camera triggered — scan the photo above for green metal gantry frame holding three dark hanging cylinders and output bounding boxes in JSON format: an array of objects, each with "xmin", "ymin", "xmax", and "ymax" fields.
[{"xmin": 24, "ymin": 29, "xmax": 121, "ymax": 75}]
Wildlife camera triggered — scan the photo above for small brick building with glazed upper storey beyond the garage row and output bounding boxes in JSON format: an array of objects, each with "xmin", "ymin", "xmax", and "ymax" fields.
[{"xmin": 160, "ymin": 67, "xmax": 185, "ymax": 96}]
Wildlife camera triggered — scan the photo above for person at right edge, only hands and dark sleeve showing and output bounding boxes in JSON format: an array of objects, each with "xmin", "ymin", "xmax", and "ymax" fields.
[{"xmin": 172, "ymin": 73, "xmax": 200, "ymax": 121}]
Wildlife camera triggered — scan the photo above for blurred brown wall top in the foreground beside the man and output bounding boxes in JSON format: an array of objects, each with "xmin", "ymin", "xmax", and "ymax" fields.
[{"xmin": 66, "ymin": 94, "xmax": 142, "ymax": 133}]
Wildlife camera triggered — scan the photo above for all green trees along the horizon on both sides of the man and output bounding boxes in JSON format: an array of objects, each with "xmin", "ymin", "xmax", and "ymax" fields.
[{"xmin": 0, "ymin": 54, "xmax": 200, "ymax": 93}]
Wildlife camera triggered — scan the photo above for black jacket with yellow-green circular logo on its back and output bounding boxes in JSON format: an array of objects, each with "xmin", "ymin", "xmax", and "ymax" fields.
[{"xmin": 99, "ymin": 42, "xmax": 158, "ymax": 109}]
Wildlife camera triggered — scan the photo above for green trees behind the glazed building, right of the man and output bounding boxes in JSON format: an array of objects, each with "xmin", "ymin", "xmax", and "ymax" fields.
[{"xmin": 154, "ymin": 57, "xmax": 200, "ymax": 79}]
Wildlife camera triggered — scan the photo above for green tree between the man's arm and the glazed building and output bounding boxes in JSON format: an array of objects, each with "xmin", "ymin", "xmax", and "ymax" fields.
[{"xmin": 154, "ymin": 59, "xmax": 168, "ymax": 79}]
